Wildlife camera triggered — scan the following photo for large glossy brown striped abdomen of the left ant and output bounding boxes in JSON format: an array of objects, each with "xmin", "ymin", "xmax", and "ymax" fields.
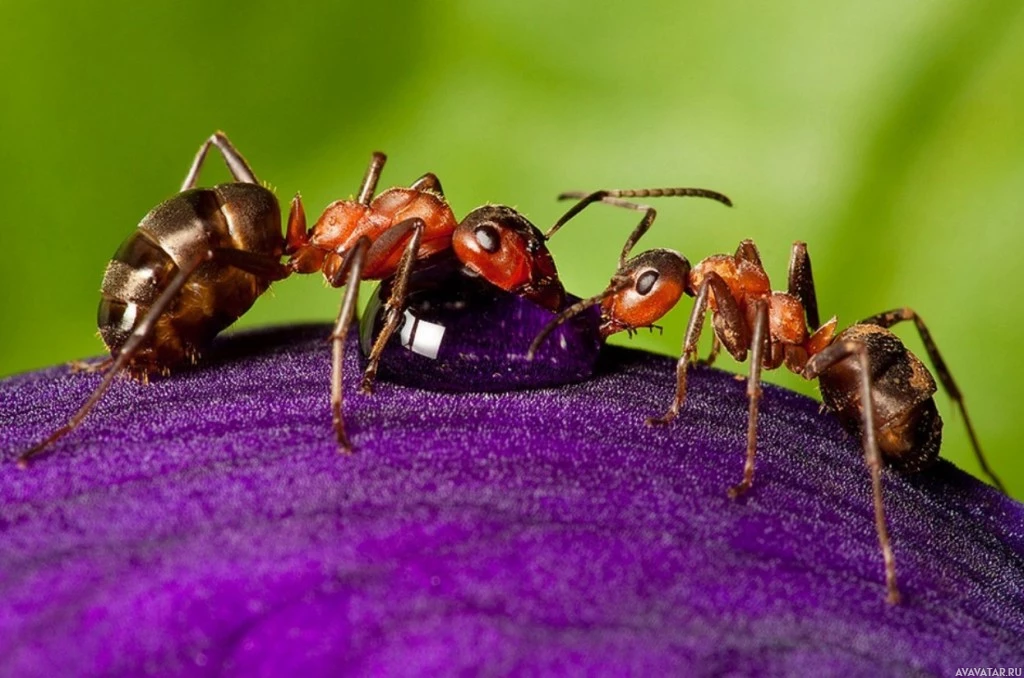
[{"xmin": 97, "ymin": 183, "xmax": 284, "ymax": 379}]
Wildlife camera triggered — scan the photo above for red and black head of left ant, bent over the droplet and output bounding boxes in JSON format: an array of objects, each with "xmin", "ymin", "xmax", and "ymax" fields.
[{"xmin": 452, "ymin": 205, "xmax": 565, "ymax": 311}]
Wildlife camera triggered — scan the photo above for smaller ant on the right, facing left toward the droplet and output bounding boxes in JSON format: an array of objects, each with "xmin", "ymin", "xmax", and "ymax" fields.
[{"xmin": 531, "ymin": 190, "xmax": 1006, "ymax": 604}]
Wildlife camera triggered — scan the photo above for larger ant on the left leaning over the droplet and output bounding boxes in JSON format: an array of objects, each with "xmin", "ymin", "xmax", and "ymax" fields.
[{"xmin": 17, "ymin": 131, "xmax": 733, "ymax": 467}]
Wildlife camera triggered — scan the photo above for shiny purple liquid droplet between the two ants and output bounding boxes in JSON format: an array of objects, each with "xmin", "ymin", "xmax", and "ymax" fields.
[{"xmin": 360, "ymin": 253, "xmax": 603, "ymax": 392}]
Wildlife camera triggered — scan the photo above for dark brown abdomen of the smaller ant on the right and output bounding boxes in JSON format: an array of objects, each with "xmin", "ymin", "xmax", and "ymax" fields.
[{"xmin": 819, "ymin": 325, "xmax": 942, "ymax": 473}]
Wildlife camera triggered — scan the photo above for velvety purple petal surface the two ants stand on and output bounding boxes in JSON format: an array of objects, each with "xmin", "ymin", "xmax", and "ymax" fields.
[{"xmin": 0, "ymin": 327, "xmax": 1024, "ymax": 676}]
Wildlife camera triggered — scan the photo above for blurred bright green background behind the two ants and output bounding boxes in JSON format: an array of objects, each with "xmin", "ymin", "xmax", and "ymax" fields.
[{"xmin": 0, "ymin": 0, "xmax": 1024, "ymax": 497}]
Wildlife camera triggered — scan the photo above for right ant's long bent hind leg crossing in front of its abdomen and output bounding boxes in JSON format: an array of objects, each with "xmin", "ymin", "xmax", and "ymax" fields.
[{"xmin": 802, "ymin": 340, "xmax": 899, "ymax": 604}]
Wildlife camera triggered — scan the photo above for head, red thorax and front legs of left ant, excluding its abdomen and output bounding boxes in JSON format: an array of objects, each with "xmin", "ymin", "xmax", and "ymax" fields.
[{"xmin": 286, "ymin": 153, "xmax": 565, "ymax": 452}]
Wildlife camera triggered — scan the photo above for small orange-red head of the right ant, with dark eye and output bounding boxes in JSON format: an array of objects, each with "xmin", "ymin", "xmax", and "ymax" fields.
[{"xmin": 601, "ymin": 250, "xmax": 692, "ymax": 336}]
